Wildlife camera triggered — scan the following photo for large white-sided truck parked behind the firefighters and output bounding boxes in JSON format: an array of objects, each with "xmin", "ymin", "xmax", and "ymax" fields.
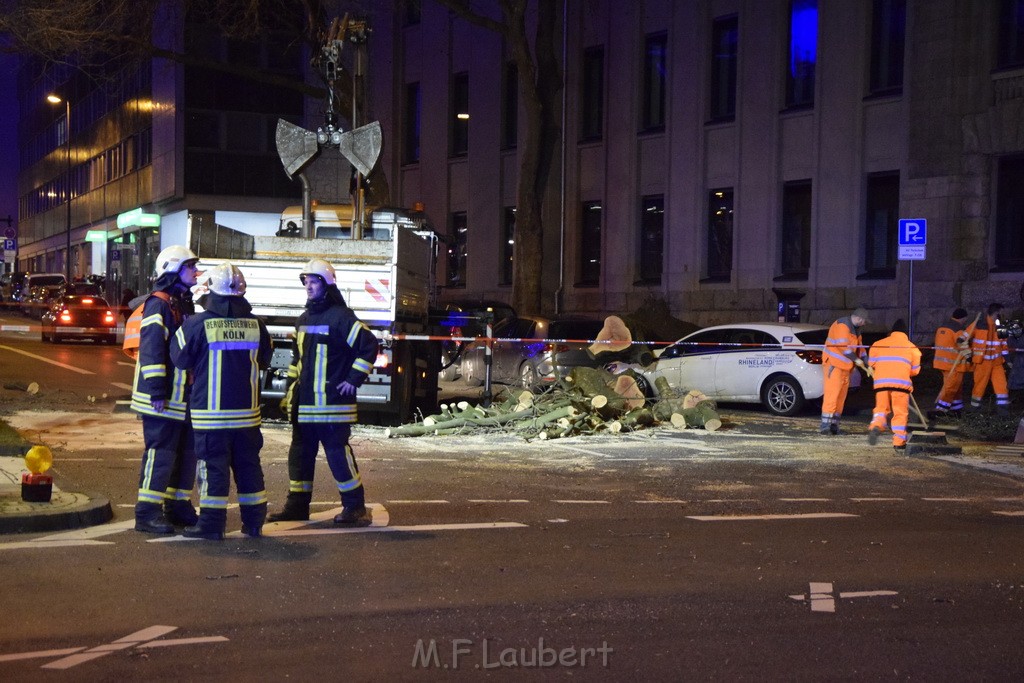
[{"xmin": 197, "ymin": 209, "xmax": 440, "ymax": 424}]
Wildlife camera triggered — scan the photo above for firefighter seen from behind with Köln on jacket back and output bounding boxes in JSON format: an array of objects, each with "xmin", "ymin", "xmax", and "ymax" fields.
[{"xmin": 171, "ymin": 262, "xmax": 272, "ymax": 540}]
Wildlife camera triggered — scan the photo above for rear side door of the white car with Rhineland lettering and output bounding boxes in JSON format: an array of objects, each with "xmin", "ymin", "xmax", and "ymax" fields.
[{"xmin": 715, "ymin": 328, "xmax": 780, "ymax": 400}]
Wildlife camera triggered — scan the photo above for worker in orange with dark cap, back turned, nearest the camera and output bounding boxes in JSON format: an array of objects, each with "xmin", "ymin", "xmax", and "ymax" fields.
[{"xmin": 867, "ymin": 318, "xmax": 921, "ymax": 452}]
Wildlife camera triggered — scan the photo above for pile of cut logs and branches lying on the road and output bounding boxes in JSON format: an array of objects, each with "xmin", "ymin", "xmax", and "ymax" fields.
[{"xmin": 385, "ymin": 368, "xmax": 722, "ymax": 440}]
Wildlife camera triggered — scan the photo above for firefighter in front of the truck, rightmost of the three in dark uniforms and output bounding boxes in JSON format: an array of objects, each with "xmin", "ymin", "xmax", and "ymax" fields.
[{"xmin": 270, "ymin": 259, "xmax": 378, "ymax": 524}]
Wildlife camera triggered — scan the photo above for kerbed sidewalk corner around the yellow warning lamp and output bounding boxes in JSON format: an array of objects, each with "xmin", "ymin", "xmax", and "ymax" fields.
[{"xmin": 0, "ymin": 421, "xmax": 114, "ymax": 533}]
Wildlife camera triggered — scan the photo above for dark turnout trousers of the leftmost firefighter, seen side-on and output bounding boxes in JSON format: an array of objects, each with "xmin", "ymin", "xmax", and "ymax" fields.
[{"xmin": 136, "ymin": 415, "xmax": 196, "ymax": 509}]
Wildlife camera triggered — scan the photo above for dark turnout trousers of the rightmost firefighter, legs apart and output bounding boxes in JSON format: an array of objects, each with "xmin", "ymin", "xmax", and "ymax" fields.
[{"xmin": 288, "ymin": 422, "xmax": 366, "ymax": 507}]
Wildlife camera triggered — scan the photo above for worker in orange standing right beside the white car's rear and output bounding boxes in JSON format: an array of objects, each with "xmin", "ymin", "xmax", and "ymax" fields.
[{"xmin": 819, "ymin": 308, "xmax": 870, "ymax": 434}]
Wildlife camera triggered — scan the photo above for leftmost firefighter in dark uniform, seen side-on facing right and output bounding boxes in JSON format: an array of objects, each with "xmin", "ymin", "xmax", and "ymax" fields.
[{"xmin": 131, "ymin": 246, "xmax": 199, "ymax": 533}]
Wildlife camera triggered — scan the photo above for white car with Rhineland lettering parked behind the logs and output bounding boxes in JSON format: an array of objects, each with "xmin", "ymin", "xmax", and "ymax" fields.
[{"xmin": 643, "ymin": 323, "xmax": 828, "ymax": 415}]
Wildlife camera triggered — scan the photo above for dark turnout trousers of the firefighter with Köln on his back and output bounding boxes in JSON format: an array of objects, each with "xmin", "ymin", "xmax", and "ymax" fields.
[{"xmin": 196, "ymin": 427, "xmax": 266, "ymax": 532}]
